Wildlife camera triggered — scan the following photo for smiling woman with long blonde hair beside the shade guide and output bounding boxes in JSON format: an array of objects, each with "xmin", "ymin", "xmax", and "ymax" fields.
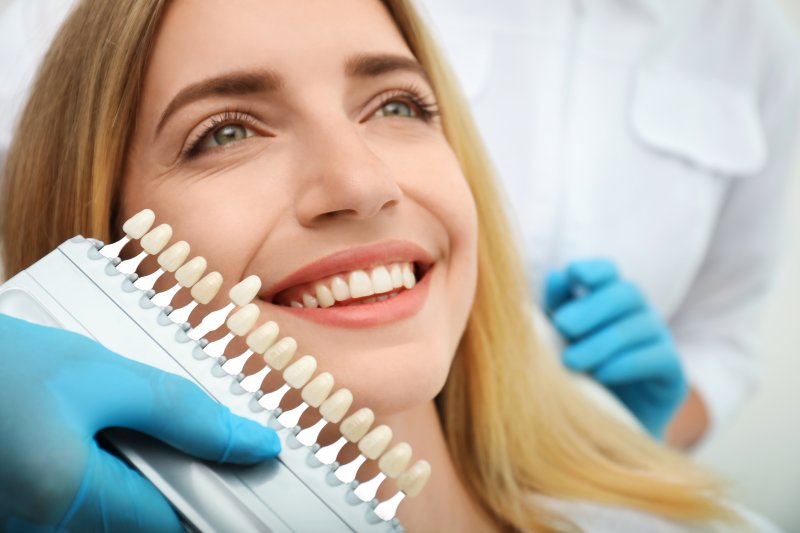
[{"xmin": 2, "ymin": 0, "xmax": 752, "ymax": 531}]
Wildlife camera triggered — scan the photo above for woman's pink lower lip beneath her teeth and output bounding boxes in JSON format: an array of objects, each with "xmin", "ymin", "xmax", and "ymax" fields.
[{"xmin": 268, "ymin": 268, "xmax": 436, "ymax": 328}]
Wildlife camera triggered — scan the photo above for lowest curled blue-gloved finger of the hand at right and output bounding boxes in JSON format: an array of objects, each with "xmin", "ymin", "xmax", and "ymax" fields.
[{"xmin": 592, "ymin": 342, "xmax": 683, "ymax": 386}]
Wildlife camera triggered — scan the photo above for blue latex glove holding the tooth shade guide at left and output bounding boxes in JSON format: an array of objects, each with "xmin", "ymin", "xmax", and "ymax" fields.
[{"xmin": 0, "ymin": 315, "xmax": 280, "ymax": 531}]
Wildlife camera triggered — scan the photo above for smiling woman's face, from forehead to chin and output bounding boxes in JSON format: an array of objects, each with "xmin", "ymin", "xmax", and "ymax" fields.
[{"xmin": 123, "ymin": 0, "xmax": 477, "ymax": 414}]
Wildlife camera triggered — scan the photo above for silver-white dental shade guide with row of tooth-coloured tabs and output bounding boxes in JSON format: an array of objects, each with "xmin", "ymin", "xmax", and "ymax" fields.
[{"xmin": 0, "ymin": 210, "xmax": 432, "ymax": 532}]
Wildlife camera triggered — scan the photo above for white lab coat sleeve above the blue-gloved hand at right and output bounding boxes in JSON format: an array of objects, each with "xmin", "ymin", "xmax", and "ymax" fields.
[{"xmin": 670, "ymin": 14, "xmax": 800, "ymax": 433}]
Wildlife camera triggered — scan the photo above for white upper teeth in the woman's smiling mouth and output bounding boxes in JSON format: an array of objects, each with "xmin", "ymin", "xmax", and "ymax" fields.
[{"xmin": 289, "ymin": 262, "xmax": 417, "ymax": 307}]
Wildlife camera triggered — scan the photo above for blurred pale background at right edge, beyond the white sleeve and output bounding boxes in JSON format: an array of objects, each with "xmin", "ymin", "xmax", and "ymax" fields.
[{"xmin": 696, "ymin": 0, "xmax": 800, "ymax": 533}]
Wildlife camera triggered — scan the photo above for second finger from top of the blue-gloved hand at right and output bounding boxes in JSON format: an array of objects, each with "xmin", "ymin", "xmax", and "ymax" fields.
[{"xmin": 553, "ymin": 281, "xmax": 646, "ymax": 340}]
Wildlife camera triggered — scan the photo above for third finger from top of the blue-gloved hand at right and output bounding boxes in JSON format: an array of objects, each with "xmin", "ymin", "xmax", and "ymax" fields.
[{"xmin": 564, "ymin": 311, "xmax": 665, "ymax": 372}]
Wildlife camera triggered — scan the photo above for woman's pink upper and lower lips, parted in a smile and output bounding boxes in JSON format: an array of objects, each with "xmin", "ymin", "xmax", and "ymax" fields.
[{"xmin": 261, "ymin": 240, "xmax": 433, "ymax": 328}]
